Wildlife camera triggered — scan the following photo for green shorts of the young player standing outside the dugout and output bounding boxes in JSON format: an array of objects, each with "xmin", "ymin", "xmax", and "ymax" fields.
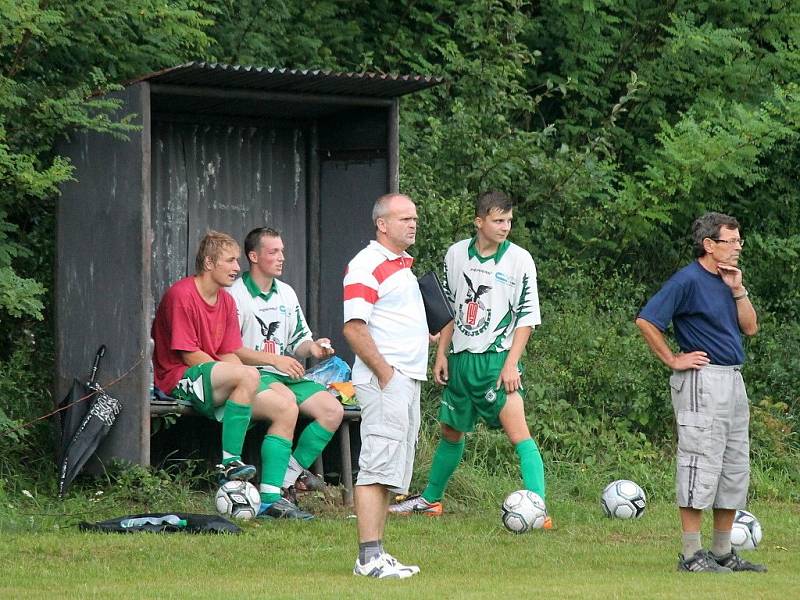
[{"xmin": 439, "ymin": 352, "xmax": 522, "ymax": 433}]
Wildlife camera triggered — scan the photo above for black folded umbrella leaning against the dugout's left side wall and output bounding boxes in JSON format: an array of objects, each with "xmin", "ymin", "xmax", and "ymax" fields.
[{"xmin": 58, "ymin": 346, "xmax": 122, "ymax": 498}]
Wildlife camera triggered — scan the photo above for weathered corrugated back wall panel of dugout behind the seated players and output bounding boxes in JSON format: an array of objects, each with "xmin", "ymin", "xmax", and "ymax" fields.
[{"xmin": 152, "ymin": 121, "xmax": 307, "ymax": 303}]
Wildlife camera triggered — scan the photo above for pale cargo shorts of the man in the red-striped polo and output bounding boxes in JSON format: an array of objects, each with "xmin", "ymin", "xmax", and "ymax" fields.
[{"xmin": 355, "ymin": 369, "xmax": 422, "ymax": 494}]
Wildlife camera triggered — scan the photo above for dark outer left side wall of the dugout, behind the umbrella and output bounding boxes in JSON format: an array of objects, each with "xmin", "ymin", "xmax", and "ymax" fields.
[{"xmin": 55, "ymin": 83, "xmax": 150, "ymax": 463}]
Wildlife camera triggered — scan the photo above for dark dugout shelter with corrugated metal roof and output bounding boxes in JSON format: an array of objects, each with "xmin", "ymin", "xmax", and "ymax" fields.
[{"xmin": 55, "ymin": 62, "xmax": 441, "ymax": 465}]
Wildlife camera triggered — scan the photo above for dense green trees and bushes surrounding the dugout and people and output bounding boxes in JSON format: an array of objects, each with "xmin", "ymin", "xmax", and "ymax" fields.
[{"xmin": 0, "ymin": 0, "xmax": 800, "ymax": 497}]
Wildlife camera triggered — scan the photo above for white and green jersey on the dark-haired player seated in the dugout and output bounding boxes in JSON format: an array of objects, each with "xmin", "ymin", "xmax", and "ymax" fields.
[{"xmin": 228, "ymin": 272, "xmax": 312, "ymax": 373}]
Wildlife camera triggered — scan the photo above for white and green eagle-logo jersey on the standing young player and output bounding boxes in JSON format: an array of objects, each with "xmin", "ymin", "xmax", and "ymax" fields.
[{"xmin": 444, "ymin": 238, "xmax": 542, "ymax": 353}]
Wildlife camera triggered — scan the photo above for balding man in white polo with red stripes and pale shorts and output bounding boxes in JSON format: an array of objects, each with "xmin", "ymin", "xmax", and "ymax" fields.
[{"xmin": 343, "ymin": 194, "xmax": 428, "ymax": 579}]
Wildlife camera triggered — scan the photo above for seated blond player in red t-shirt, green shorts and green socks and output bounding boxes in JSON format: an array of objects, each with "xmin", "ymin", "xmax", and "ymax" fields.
[{"xmin": 151, "ymin": 231, "xmax": 312, "ymax": 519}]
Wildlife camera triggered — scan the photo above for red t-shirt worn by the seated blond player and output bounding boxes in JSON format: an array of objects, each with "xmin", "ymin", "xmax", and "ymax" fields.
[{"xmin": 150, "ymin": 277, "xmax": 242, "ymax": 394}]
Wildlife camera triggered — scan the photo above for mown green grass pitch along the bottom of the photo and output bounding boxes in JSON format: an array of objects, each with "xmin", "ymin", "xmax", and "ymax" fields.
[{"xmin": 0, "ymin": 501, "xmax": 800, "ymax": 599}]
